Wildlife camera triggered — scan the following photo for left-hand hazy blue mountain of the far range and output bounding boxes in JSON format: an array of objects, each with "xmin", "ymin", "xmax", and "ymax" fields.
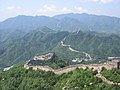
[{"xmin": 0, "ymin": 15, "xmax": 58, "ymax": 42}]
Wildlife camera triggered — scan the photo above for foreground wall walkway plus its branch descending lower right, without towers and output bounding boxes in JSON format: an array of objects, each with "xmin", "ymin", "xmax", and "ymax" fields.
[{"xmin": 24, "ymin": 60, "xmax": 120, "ymax": 86}]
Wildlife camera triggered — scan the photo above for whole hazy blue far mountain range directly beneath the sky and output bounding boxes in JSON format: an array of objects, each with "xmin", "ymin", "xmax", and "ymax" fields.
[{"xmin": 0, "ymin": 13, "xmax": 120, "ymax": 42}]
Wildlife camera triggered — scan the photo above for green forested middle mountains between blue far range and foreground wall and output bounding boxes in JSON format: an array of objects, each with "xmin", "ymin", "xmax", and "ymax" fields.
[{"xmin": 0, "ymin": 27, "xmax": 120, "ymax": 68}]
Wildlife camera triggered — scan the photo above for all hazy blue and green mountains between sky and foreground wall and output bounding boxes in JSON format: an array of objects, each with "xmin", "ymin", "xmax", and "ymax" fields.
[{"xmin": 0, "ymin": 13, "xmax": 120, "ymax": 68}]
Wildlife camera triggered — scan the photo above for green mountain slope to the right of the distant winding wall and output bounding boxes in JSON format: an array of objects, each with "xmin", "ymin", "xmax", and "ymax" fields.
[{"xmin": 64, "ymin": 31, "xmax": 120, "ymax": 58}]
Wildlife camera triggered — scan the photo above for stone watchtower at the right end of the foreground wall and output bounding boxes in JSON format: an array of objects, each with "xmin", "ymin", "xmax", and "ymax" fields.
[{"xmin": 107, "ymin": 57, "xmax": 120, "ymax": 69}]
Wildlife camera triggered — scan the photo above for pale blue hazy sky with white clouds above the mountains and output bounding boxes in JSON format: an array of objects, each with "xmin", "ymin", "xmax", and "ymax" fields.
[{"xmin": 0, "ymin": 0, "xmax": 120, "ymax": 21}]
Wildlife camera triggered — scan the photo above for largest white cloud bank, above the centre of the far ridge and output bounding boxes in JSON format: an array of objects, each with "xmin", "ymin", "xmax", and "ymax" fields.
[{"xmin": 37, "ymin": 4, "xmax": 87, "ymax": 16}]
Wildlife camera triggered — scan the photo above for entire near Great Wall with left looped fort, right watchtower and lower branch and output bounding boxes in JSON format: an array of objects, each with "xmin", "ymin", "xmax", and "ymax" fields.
[{"xmin": 24, "ymin": 53, "xmax": 120, "ymax": 86}]
